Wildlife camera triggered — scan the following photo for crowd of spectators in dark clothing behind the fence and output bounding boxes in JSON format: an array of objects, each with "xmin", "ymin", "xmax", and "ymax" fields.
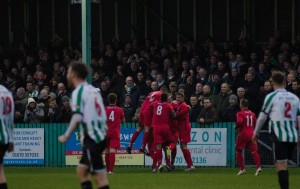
[{"xmin": 0, "ymin": 32, "xmax": 300, "ymax": 123}]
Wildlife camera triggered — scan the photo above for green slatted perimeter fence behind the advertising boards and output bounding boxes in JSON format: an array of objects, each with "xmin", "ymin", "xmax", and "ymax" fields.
[{"xmin": 15, "ymin": 122, "xmax": 235, "ymax": 167}]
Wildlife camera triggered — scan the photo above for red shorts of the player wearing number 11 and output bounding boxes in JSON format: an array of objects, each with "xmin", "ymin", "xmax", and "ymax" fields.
[{"xmin": 235, "ymin": 134, "xmax": 258, "ymax": 151}]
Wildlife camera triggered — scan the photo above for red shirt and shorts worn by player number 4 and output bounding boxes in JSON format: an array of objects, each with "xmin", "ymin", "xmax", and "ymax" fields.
[{"xmin": 105, "ymin": 105, "xmax": 124, "ymax": 149}]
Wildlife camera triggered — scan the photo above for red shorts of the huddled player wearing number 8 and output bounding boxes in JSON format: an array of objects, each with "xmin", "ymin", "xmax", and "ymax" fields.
[{"xmin": 153, "ymin": 126, "xmax": 174, "ymax": 144}]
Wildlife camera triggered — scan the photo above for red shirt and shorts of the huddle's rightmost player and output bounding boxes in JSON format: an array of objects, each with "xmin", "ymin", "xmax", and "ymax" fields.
[{"xmin": 176, "ymin": 102, "xmax": 191, "ymax": 143}]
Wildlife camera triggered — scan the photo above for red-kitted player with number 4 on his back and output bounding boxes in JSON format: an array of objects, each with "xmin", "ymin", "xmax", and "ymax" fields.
[{"xmin": 105, "ymin": 93, "xmax": 125, "ymax": 174}]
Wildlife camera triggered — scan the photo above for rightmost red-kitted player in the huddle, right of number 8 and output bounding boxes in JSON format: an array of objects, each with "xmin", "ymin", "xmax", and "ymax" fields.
[{"xmin": 176, "ymin": 92, "xmax": 195, "ymax": 171}]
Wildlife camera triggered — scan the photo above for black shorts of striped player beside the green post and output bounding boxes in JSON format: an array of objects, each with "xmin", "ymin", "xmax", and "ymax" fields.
[{"xmin": 79, "ymin": 137, "xmax": 105, "ymax": 173}]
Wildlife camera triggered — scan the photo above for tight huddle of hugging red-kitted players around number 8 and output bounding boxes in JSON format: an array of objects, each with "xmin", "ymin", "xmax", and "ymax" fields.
[{"xmin": 127, "ymin": 87, "xmax": 195, "ymax": 172}]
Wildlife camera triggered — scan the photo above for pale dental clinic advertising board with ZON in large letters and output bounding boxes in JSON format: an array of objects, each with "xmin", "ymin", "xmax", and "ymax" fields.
[{"xmin": 146, "ymin": 128, "xmax": 227, "ymax": 166}]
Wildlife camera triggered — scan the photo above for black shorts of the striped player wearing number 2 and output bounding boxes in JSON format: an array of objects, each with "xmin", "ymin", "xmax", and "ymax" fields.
[{"xmin": 273, "ymin": 142, "xmax": 297, "ymax": 162}]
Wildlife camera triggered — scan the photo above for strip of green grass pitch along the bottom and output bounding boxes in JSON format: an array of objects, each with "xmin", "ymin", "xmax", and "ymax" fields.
[{"xmin": 5, "ymin": 167, "xmax": 300, "ymax": 189}]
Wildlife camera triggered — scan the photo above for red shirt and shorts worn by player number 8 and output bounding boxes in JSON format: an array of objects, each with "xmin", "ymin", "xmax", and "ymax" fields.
[{"xmin": 151, "ymin": 101, "xmax": 174, "ymax": 144}]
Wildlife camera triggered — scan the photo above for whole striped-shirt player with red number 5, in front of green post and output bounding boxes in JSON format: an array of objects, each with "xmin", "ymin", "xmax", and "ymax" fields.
[{"xmin": 59, "ymin": 62, "xmax": 109, "ymax": 189}]
